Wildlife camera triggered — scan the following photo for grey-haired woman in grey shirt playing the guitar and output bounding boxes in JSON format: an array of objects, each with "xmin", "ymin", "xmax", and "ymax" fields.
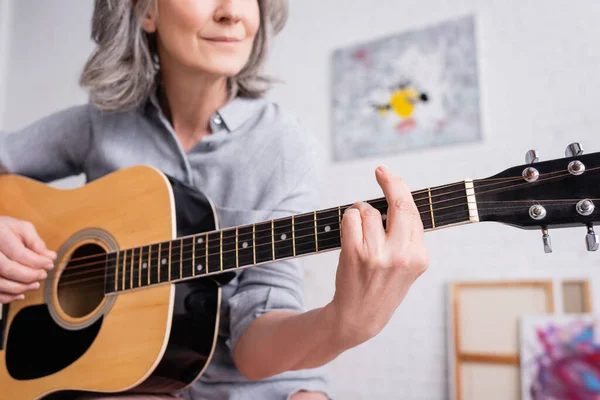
[{"xmin": 0, "ymin": 0, "xmax": 428, "ymax": 400}]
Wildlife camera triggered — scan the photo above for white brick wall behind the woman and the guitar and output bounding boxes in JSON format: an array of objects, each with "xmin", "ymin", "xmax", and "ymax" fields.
[{"xmin": 0, "ymin": 0, "xmax": 600, "ymax": 400}]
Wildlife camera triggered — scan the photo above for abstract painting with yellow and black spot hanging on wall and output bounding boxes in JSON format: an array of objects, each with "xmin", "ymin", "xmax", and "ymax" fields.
[{"xmin": 332, "ymin": 16, "xmax": 482, "ymax": 161}]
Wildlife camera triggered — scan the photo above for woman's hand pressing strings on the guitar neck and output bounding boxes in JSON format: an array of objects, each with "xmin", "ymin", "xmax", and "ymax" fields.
[{"xmin": 326, "ymin": 167, "xmax": 429, "ymax": 348}]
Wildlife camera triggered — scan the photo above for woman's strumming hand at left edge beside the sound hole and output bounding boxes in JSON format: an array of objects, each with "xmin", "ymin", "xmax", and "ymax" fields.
[{"xmin": 0, "ymin": 217, "xmax": 56, "ymax": 304}]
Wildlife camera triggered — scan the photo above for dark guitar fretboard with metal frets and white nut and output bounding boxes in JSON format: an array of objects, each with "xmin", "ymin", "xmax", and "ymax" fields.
[{"xmin": 105, "ymin": 181, "xmax": 479, "ymax": 294}]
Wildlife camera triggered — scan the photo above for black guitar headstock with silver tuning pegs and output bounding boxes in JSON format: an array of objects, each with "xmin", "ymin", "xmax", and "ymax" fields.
[{"xmin": 473, "ymin": 143, "xmax": 600, "ymax": 253}]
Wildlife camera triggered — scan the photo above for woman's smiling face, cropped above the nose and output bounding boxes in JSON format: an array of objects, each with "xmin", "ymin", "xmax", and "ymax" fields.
[{"xmin": 143, "ymin": 0, "xmax": 260, "ymax": 76}]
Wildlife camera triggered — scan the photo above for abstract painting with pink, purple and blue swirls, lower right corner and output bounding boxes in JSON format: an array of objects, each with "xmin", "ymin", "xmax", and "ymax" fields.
[{"xmin": 520, "ymin": 314, "xmax": 600, "ymax": 400}]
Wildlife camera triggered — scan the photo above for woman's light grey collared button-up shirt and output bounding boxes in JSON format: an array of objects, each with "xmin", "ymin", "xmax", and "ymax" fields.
[{"xmin": 0, "ymin": 92, "xmax": 331, "ymax": 400}]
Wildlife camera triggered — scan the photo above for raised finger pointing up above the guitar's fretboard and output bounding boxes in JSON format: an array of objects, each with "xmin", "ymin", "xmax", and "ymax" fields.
[{"xmin": 375, "ymin": 167, "xmax": 421, "ymax": 240}]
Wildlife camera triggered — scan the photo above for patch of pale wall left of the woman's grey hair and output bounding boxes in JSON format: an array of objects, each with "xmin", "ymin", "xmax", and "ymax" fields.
[{"xmin": 0, "ymin": 0, "xmax": 93, "ymax": 188}]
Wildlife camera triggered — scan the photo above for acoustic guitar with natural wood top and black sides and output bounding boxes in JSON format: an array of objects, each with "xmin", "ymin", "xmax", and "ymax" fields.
[{"xmin": 0, "ymin": 143, "xmax": 600, "ymax": 399}]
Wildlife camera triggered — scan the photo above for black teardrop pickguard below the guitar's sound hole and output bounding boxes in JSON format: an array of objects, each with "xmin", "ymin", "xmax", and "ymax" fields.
[{"xmin": 6, "ymin": 304, "xmax": 102, "ymax": 380}]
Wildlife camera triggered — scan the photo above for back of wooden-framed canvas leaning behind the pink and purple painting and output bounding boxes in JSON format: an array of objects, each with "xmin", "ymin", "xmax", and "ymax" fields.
[{"xmin": 449, "ymin": 280, "xmax": 554, "ymax": 400}]
